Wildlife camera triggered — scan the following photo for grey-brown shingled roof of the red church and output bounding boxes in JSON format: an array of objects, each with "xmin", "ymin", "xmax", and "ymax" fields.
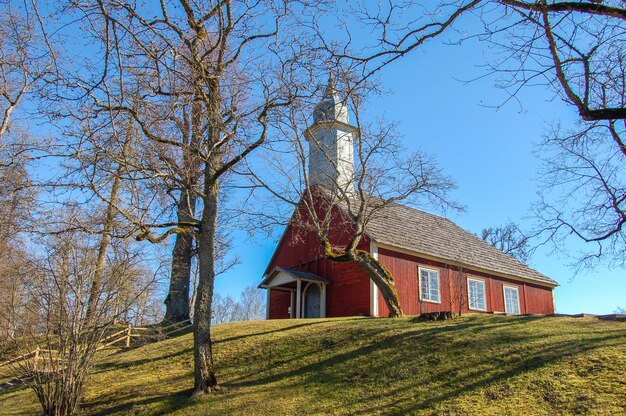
[{"xmin": 366, "ymin": 204, "xmax": 558, "ymax": 286}]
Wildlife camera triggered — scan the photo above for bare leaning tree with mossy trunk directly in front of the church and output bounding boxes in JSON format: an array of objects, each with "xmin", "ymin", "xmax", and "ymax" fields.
[{"xmin": 250, "ymin": 71, "xmax": 455, "ymax": 317}]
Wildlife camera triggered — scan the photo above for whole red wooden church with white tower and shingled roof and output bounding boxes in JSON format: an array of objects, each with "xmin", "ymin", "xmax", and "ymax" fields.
[{"xmin": 260, "ymin": 79, "xmax": 557, "ymax": 319}]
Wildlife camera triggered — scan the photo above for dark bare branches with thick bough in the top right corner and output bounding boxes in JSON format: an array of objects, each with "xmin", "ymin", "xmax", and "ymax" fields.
[{"xmin": 482, "ymin": 0, "xmax": 626, "ymax": 122}]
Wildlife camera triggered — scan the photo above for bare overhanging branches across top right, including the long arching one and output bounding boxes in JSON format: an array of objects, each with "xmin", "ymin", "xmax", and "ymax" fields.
[{"xmin": 320, "ymin": 0, "xmax": 626, "ymax": 122}]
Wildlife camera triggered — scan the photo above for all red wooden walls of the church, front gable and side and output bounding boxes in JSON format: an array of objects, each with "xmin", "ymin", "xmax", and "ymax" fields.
[{"xmin": 266, "ymin": 192, "xmax": 554, "ymax": 319}]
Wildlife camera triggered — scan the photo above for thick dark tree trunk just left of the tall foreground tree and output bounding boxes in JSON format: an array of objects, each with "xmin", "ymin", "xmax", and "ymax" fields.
[{"xmin": 164, "ymin": 190, "xmax": 196, "ymax": 322}]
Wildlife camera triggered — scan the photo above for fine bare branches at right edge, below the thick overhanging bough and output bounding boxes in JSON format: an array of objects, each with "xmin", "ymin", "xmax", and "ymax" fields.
[{"xmin": 534, "ymin": 125, "xmax": 626, "ymax": 268}]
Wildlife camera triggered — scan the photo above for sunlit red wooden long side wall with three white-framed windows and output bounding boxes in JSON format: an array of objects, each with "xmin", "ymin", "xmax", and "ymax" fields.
[{"xmin": 378, "ymin": 248, "xmax": 554, "ymax": 316}]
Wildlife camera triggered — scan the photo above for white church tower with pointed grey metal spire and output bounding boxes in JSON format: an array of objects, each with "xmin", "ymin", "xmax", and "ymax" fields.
[{"xmin": 304, "ymin": 77, "xmax": 357, "ymax": 195}]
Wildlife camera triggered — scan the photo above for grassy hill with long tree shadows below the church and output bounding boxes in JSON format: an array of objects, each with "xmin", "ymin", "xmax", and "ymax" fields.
[{"xmin": 0, "ymin": 315, "xmax": 626, "ymax": 415}]
